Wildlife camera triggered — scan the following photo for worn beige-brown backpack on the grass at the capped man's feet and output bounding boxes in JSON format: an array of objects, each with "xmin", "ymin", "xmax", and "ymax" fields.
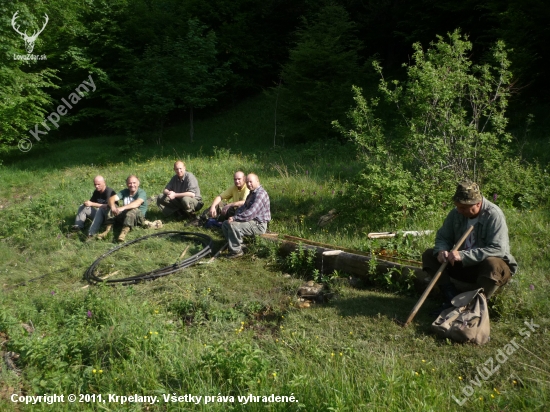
[{"xmin": 432, "ymin": 288, "xmax": 491, "ymax": 345}]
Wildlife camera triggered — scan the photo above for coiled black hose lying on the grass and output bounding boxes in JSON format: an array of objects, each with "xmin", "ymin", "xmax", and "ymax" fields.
[{"xmin": 84, "ymin": 231, "xmax": 212, "ymax": 285}]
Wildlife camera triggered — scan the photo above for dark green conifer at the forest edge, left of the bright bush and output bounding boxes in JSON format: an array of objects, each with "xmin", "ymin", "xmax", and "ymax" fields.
[{"xmin": 280, "ymin": 4, "xmax": 361, "ymax": 140}]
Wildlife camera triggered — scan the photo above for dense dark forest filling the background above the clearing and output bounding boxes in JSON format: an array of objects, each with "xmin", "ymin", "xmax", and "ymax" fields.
[{"xmin": 0, "ymin": 0, "xmax": 550, "ymax": 151}]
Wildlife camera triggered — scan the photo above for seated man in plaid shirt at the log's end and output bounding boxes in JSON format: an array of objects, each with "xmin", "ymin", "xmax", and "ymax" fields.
[{"xmin": 222, "ymin": 173, "xmax": 271, "ymax": 259}]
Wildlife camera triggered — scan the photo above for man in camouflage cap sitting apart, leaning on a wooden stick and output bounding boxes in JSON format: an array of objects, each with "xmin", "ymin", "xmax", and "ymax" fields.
[{"xmin": 422, "ymin": 181, "xmax": 517, "ymax": 310}]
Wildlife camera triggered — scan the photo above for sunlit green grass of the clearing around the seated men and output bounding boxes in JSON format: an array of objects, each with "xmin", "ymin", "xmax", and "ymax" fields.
[{"xmin": 0, "ymin": 97, "xmax": 550, "ymax": 411}]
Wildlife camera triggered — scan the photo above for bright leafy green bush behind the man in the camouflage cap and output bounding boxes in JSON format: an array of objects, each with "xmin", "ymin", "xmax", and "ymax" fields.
[{"xmin": 336, "ymin": 31, "xmax": 511, "ymax": 222}]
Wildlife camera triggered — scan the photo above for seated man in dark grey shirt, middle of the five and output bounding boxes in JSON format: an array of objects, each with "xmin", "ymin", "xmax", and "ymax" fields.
[{"xmin": 157, "ymin": 161, "xmax": 203, "ymax": 220}]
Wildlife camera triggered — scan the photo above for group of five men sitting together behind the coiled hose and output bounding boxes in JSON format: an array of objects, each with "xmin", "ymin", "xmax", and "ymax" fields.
[{"xmin": 72, "ymin": 161, "xmax": 271, "ymax": 258}]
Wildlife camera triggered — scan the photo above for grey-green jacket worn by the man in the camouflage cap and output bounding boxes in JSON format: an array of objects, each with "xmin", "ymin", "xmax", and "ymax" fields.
[{"xmin": 434, "ymin": 198, "xmax": 518, "ymax": 274}]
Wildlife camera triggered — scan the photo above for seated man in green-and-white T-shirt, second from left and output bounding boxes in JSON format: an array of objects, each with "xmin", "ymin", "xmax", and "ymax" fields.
[{"xmin": 93, "ymin": 175, "xmax": 147, "ymax": 242}]
